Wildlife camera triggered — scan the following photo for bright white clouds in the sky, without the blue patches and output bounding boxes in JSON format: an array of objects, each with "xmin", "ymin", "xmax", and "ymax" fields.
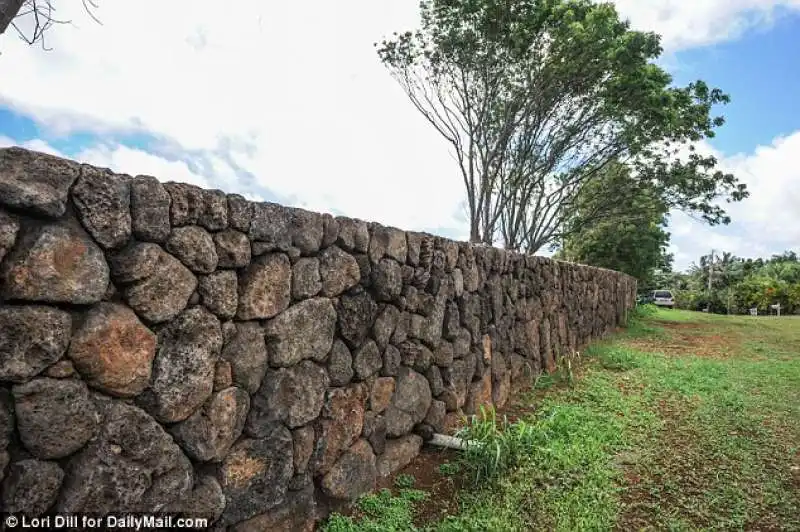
[{"xmin": 0, "ymin": 0, "xmax": 800, "ymax": 253}]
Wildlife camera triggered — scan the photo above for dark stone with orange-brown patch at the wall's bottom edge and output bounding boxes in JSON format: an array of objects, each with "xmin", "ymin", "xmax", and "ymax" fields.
[{"xmin": 219, "ymin": 426, "xmax": 294, "ymax": 525}]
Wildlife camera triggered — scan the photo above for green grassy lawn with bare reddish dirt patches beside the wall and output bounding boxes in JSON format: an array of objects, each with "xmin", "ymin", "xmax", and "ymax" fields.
[{"xmin": 322, "ymin": 311, "xmax": 800, "ymax": 532}]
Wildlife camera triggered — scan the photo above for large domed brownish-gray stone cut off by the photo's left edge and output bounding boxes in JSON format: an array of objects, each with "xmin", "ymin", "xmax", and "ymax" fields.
[{"xmin": 0, "ymin": 223, "xmax": 109, "ymax": 305}]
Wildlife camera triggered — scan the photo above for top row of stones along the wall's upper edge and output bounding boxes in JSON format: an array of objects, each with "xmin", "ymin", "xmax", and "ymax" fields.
[{"xmin": 0, "ymin": 147, "xmax": 635, "ymax": 281}]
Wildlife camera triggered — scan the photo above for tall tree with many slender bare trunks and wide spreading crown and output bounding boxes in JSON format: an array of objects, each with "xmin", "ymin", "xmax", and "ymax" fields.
[{"xmin": 376, "ymin": 0, "xmax": 747, "ymax": 253}]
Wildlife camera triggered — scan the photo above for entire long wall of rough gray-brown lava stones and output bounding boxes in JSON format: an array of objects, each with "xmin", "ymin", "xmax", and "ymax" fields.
[{"xmin": 0, "ymin": 148, "xmax": 635, "ymax": 530}]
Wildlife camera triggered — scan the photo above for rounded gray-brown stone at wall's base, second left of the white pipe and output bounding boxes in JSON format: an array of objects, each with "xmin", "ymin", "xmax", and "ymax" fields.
[{"xmin": 320, "ymin": 440, "xmax": 377, "ymax": 500}]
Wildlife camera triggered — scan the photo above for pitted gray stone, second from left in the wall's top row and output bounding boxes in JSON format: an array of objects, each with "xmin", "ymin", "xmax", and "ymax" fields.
[{"xmin": 72, "ymin": 165, "xmax": 132, "ymax": 249}]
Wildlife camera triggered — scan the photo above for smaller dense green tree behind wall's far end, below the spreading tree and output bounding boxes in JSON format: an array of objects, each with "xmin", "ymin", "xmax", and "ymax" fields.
[{"xmin": 556, "ymin": 163, "xmax": 672, "ymax": 289}]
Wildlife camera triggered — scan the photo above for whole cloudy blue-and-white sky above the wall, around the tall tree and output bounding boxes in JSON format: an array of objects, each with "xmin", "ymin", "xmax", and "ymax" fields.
[{"xmin": 0, "ymin": 0, "xmax": 800, "ymax": 269}]
